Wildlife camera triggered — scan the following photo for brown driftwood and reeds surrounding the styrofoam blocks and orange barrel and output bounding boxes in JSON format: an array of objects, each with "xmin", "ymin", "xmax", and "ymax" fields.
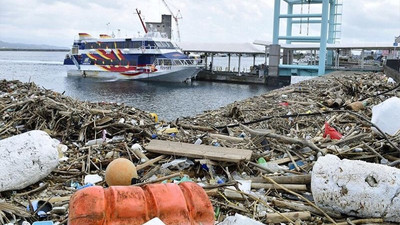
[{"xmin": 0, "ymin": 72, "xmax": 400, "ymax": 224}]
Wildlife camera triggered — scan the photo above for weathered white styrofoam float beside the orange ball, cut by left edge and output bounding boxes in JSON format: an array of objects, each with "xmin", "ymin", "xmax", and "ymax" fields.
[{"xmin": 0, "ymin": 130, "xmax": 58, "ymax": 192}]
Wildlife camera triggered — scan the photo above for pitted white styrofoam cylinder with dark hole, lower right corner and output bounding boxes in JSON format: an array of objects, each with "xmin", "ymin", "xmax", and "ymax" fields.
[{"xmin": 311, "ymin": 155, "xmax": 400, "ymax": 222}]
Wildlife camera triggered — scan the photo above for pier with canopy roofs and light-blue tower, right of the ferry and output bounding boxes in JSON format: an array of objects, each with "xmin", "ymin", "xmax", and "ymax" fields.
[{"xmin": 182, "ymin": 0, "xmax": 400, "ymax": 85}]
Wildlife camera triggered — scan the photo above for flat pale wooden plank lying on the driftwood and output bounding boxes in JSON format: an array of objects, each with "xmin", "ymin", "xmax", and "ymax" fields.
[{"xmin": 146, "ymin": 140, "xmax": 253, "ymax": 162}]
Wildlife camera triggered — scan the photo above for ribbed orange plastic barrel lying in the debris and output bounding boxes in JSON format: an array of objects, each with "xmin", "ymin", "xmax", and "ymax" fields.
[{"xmin": 68, "ymin": 182, "xmax": 214, "ymax": 225}]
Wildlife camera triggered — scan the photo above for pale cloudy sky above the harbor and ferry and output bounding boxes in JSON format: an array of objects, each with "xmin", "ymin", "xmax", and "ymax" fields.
[{"xmin": 0, "ymin": 0, "xmax": 400, "ymax": 47}]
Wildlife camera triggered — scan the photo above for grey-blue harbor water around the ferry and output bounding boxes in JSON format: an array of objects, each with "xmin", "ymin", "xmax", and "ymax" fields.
[{"xmin": 0, "ymin": 51, "xmax": 272, "ymax": 121}]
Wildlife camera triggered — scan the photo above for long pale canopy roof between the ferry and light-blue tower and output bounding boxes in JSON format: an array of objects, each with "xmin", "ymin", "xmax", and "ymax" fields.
[{"xmin": 179, "ymin": 42, "xmax": 265, "ymax": 54}]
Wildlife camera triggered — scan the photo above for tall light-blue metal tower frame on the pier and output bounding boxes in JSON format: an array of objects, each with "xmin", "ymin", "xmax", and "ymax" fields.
[{"xmin": 270, "ymin": 0, "xmax": 343, "ymax": 76}]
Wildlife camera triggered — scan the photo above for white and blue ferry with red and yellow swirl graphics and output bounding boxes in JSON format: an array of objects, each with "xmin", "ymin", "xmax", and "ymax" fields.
[{"xmin": 64, "ymin": 32, "xmax": 202, "ymax": 82}]
